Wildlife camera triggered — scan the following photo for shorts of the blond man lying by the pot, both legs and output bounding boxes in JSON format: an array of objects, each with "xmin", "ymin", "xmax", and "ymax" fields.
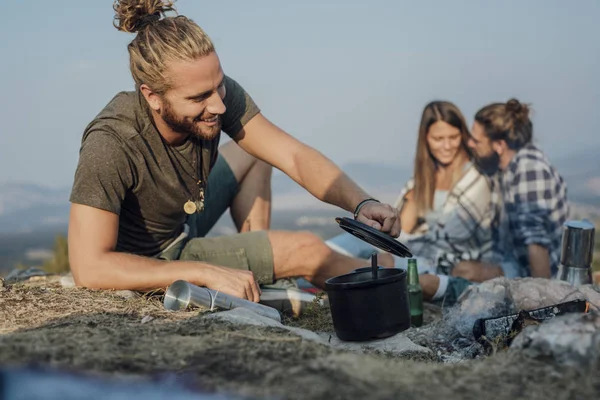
[{"xmin": 159, "ymin": 155, "xmax": 273, "ymax": 284}]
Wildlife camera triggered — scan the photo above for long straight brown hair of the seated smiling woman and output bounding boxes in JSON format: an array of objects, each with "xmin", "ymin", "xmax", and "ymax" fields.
[{"xmin": 413, "ymin": 101, "xmax": 472, "ymax": 217}]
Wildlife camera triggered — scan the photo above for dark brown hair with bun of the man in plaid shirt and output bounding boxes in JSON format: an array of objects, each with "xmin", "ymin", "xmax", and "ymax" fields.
[{"xmin": 475, "ymin": 99, "xmax": 533, "ymax": 150}]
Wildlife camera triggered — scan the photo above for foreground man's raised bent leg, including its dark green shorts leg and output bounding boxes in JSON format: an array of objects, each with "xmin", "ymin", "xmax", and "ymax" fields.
[{"xmin": 188, "ymin": 141, "xmax": 271, "ymax": 237}]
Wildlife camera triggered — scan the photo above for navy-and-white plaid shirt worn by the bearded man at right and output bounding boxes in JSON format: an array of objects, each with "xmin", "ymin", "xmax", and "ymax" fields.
[{"xmin": 493, "ymin": 144, "xmax": 569, "ymax": 276}]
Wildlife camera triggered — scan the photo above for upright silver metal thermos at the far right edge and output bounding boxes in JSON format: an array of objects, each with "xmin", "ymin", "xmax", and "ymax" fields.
[{"xmin": 557, "ymin": 219, "xmax": 595, "ymax": 286}]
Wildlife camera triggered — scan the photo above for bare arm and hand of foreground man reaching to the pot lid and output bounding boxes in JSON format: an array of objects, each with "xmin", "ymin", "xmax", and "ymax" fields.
[{"xmin": 235, "ymin": 113, "xmax": 400, "ymax": 237}]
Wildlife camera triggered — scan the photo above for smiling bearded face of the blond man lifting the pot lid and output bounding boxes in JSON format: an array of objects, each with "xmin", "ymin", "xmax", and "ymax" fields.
[{"xmin": 149, "ymin": 52, "xmax": 226, "ymax": 140}]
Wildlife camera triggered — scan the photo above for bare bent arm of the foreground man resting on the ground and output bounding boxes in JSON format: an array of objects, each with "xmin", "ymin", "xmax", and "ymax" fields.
[{"xmin": 68, "ymin": 203, "xmax": 260, "ymax": 301}]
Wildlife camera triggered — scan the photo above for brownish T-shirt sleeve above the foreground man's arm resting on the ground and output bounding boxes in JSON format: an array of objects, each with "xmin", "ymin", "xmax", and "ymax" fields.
[{"xmin": 70, "ymin": 131, "xmax": 134, "ymax": 215}]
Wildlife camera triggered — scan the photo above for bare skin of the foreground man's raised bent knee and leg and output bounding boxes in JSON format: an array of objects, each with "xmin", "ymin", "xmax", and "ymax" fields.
[{"xmin": 219, "ymin": 141, "xmax": 272, "ymax": 232}]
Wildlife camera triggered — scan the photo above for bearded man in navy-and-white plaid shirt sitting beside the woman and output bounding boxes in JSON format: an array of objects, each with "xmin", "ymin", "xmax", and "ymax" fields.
[{"xmin": 421, "ymin": 99, "xmax": 569, "ymax": 303}]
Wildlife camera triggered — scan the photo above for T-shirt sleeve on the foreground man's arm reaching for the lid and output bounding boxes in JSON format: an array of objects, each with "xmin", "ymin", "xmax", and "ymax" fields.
[{"xmin": 222, "ymin": 76, "xmax": 260, "ymax": 138}]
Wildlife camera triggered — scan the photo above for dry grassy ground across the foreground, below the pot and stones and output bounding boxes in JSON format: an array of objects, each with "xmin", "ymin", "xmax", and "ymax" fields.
[{"xmin": 0, "ymin": 278, "xmax": 600, "ymax": 400}]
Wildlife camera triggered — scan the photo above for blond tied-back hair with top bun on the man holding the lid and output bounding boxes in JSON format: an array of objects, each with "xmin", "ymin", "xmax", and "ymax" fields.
[{"xmin": 113, "ymin": 0, "xmax": 215, "ymax": 95}]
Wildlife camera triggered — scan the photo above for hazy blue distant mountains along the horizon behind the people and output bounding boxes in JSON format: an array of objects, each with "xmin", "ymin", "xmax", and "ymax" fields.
[{"xmin": 0, "ymin": 148, "xmax": 600, "ymax": 233}]
